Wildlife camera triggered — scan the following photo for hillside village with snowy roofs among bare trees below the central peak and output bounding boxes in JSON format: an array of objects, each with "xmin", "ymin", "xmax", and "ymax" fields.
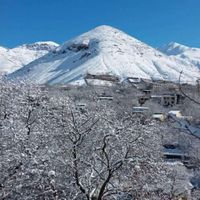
[{"xmin": 52, "ymin": 74, "xmax": 200, "ymax": 199}]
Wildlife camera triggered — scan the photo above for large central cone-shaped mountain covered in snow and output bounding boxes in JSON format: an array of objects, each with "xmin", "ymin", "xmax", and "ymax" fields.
[{"xmin": 10, "ymin": 25, "xmax": 200, "ymax": 84}]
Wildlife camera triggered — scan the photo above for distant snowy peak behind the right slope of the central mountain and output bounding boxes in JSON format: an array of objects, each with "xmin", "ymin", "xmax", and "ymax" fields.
[{"xmin": 158, "ymin": 42, "xmax": 200, "ymax": 69}]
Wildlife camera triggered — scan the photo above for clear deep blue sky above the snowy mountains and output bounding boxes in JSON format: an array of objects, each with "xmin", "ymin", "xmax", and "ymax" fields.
[{"xmin": 0, "ymin": 0, "xmax": 200, "ymax": 47}]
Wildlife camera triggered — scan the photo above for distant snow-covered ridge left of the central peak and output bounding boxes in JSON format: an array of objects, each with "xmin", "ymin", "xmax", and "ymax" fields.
[{"xmin": 0, "ymin": 41, "xmax": 59, "ymax": 73}]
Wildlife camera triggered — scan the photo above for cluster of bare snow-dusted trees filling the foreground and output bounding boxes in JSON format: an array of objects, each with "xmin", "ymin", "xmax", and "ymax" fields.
[{"xmin": 0, "ymin": 77, "xmax": 191, "ymax": 200}]
